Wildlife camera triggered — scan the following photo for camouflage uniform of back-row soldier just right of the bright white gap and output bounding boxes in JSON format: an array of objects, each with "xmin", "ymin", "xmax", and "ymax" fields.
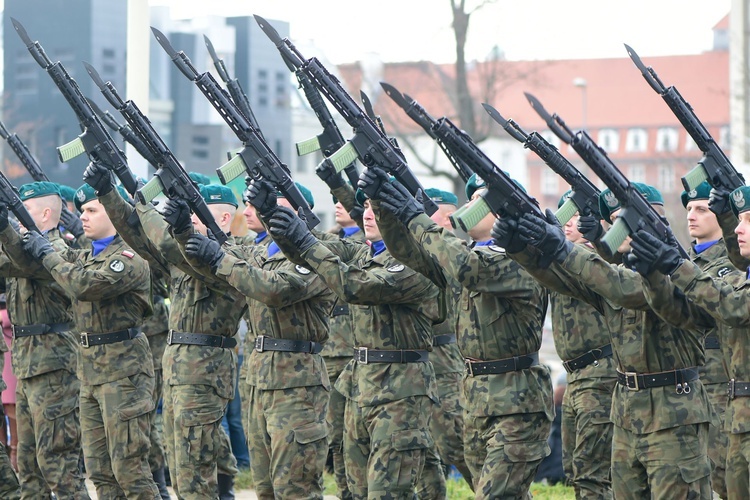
[{"xmin": 550, "ymin": 244, "xmax": 617, "ymax": 498}]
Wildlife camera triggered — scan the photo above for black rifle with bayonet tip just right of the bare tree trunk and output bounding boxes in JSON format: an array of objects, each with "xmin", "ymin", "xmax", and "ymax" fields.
[{"xmin": 482, "ymin": 103, "xmax": 602, "ymax": 226}]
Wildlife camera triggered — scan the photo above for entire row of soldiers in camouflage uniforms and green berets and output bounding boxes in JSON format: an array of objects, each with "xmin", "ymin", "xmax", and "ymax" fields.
[{"xmin": 0, "ymin": 153, "xmax": 750, "ymax": 498}]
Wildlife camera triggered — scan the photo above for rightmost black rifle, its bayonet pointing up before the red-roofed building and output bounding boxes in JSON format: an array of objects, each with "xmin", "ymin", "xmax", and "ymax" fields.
[{"xmin": 625, "ymin": 44, "xmax": 745, "ymax": 191}]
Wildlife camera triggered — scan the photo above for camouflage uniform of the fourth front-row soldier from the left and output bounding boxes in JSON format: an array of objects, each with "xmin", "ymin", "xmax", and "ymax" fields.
[{"xmin": 184, "ymin": 235, "xmax": 334, "ymax": 499}]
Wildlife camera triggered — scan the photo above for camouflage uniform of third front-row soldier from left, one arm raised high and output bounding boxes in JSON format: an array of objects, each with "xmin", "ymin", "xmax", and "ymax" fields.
[{"xmin": 99, "ymin": 190, "xmax": 245, "ymax": 498}]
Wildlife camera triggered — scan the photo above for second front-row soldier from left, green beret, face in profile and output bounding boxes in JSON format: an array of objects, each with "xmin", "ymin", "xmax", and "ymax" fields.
[{"xmin": 23, "ymin": 185, "xmax": 159, "ymax": 499}]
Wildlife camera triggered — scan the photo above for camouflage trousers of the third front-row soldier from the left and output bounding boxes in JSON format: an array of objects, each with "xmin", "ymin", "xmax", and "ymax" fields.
[{"xmin": 162, "ymin": 384, "xmax": 238, "ymax": 499}]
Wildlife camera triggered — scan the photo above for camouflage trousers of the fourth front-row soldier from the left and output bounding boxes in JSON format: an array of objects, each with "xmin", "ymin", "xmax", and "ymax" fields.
[{"xmin": 247, "ymin": 385, "xmax": 329, "ymax": 500}]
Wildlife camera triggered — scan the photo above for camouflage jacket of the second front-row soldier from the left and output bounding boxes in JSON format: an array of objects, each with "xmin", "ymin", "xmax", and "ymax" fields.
[{"xmin": 42, "ymin": 236, "xmax": 154, "ymax": 385}]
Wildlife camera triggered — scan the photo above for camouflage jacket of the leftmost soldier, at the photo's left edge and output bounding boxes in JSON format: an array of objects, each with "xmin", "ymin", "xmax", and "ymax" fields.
[{"xmin": 0, "ymin": 225, "xmax": 78, "ymax": 379}]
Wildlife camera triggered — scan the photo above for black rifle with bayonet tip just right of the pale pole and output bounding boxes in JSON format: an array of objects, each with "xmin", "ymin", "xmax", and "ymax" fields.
[{"xmin": 151, "ymin": 27, "xmax": 320, "ymax": 229}]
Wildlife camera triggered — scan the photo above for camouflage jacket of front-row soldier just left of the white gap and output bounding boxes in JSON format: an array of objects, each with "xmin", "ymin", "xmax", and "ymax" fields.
[{"xmin": 382, "ymin": 211, "xmax": 554, "ymax": 420}]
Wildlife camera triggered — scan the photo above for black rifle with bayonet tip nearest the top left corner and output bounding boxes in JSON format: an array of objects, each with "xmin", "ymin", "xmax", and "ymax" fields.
[{"xmin": 11, "ymin": 17, "xmax": 138, "ymax": 195}]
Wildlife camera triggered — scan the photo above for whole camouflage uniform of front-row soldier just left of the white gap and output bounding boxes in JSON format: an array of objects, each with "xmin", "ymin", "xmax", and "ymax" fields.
[{"xmin": 374, "ymin": 209, "xmax": 554, "ymax": 498}]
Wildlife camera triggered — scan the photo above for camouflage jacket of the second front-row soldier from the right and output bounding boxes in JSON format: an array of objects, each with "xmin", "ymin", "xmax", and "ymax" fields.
[{"xmin": 513, "ymin": 246, "xmax": 712, "ymax": 434}]
